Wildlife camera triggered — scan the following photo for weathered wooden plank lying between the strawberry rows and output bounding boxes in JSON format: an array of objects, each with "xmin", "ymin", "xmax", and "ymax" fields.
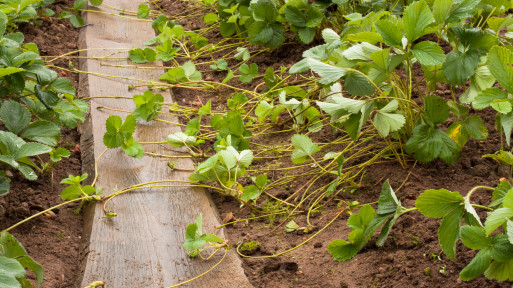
[{"xmin": 78, "ymin": 0, "xmax": 251, "ymax": 288}]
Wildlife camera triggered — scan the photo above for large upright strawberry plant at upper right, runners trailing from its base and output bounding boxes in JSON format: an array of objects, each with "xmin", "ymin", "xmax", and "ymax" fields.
[{"xmin": 290, "ymin": 0, "xmax": 509, "ymax": 163}]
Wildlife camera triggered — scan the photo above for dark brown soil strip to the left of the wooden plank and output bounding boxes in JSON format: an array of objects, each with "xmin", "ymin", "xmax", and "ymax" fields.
[{"xmin": 0, "ymin": 0, "xmax": 82, "ymax": 288}]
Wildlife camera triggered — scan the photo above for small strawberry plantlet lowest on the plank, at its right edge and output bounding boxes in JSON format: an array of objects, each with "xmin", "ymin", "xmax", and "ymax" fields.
[{"xmin": 183, "ymin": 213, "xmax": 225, "ymax": 260}]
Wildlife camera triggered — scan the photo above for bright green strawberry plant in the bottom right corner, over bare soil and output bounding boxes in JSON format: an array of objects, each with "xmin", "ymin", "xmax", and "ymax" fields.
[{"xmin": 328, "ymin": 181, "xmax": 513, "ymax": 281}]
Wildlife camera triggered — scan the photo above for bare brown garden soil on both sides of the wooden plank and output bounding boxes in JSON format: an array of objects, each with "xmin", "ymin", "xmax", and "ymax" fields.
[{"xmin": 0, "ymin": 1, "xmax": 511, "ymax": 287}]
